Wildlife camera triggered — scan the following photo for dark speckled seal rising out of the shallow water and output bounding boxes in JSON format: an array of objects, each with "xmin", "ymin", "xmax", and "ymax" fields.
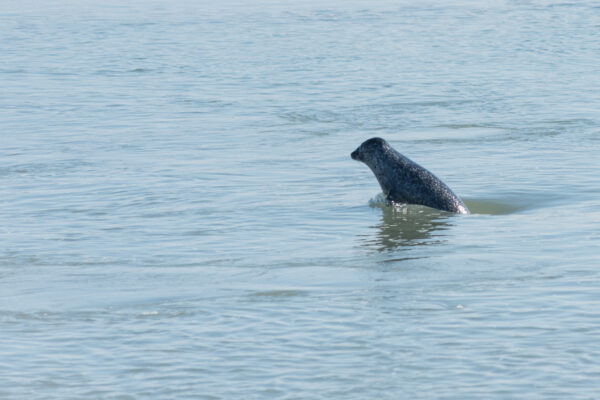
[{"xmin": 350, "ymin": 137, "xmax": 469, "ymax": 214}]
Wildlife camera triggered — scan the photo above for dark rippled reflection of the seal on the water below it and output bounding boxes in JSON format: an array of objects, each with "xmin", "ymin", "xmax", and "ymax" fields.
[{"xmin": 363, "ymin": 203, "xmax": 452, "ymax": 251}]
